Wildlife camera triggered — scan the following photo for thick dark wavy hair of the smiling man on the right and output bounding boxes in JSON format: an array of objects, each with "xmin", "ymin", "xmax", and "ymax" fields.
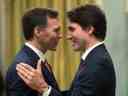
[{"xmin": 67, "ymin": 4, "xmax": 107, "ymax": 40}]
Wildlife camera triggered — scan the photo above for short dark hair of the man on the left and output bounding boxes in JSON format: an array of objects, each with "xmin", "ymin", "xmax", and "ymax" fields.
[{"xmin": 22, "ymin": 8, "xmax": 58, "ymax": 40}]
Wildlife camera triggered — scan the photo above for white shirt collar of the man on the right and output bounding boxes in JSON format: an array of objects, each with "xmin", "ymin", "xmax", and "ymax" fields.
[{"xmin": 81, "ymin": 41, "xmax": 104, "ymax": 60}]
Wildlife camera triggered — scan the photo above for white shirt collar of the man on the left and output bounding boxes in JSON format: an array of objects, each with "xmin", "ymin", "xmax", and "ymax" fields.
[{"xmin": 25, "ymin": 42, "xmax": 45, "ymax": 61}]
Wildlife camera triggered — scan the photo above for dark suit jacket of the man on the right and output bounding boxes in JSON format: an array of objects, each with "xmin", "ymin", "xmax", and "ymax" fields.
[{"xmin": 51, "ymin": 44, "xmax": 116, "ymax": 96}]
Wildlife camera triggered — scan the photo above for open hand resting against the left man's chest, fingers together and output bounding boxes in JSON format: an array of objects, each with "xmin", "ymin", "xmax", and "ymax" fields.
[{"xmin": 16, "ymin": 60, "xmax": 48, "ymax": 93}]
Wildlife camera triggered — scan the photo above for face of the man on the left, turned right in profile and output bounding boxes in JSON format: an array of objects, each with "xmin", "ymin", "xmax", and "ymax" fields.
[{"xmin": 37, "ymin": 18, "xmax": 61, "ymax": 50}]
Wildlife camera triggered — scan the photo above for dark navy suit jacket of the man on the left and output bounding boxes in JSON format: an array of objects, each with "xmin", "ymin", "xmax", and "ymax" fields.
[{"xmin": 6, "ymin": 46, "xmax": 59, "ymax": 96}]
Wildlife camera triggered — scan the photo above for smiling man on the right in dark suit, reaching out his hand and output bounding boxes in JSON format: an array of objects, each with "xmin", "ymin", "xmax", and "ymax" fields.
[{"xmin": 18, "ymin": 5, "xmax": 116, "ymax": 96}]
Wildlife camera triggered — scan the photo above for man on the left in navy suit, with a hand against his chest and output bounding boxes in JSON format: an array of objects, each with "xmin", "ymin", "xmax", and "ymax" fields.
[{"xmin": 6, "ymin": 8, "xmax": 61, "ymax": 96}]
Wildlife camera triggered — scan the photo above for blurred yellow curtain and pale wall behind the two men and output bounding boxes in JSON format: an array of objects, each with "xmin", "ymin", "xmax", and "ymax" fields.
[{"xmin": 0, "ymin": 0, "xmax": 128, "ymax": 96}]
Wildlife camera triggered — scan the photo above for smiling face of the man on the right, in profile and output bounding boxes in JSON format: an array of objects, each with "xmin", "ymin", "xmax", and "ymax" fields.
[{"xmin": 67, "ymin": 22, "xmax": 88, "ymax": 51}]
